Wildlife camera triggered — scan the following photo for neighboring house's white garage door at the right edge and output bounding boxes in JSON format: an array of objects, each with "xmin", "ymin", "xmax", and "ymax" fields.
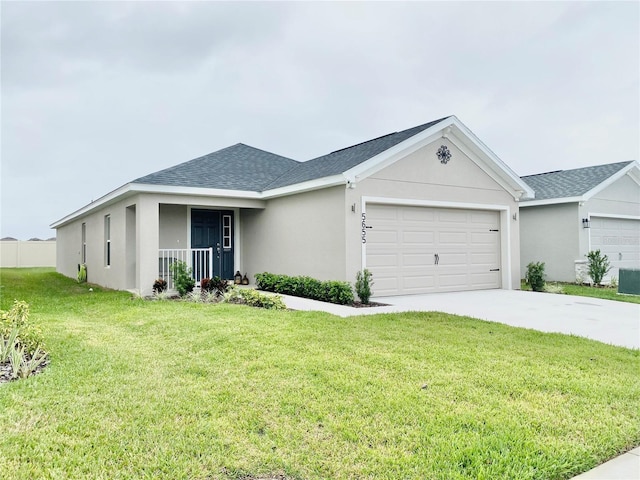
[{"xmin": 589, "ymin": 217, "xmax": 640, "ymax": 281}]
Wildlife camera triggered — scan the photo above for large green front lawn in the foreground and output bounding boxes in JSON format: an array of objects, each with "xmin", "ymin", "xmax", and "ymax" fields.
[{"xmin": 0, "ymin": 269, "xmax": 640, "ymax": 479}]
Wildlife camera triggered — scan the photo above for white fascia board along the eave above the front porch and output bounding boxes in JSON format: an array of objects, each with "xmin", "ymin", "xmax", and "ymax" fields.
[{"xmin": 50, "ymin": 183, "xmax": 261, "ymax": 228}]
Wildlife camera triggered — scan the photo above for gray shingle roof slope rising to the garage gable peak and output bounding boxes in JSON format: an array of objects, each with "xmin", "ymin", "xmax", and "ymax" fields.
[{"xmin": 267, "ymin": 117, "xmax": 448, "ymax": 189}]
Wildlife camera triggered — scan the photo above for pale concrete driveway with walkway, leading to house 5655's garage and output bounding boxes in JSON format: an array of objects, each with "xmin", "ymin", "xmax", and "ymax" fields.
[{"xmin": 283, "ymin": 290, "xmax": 640, "ymax": 348}]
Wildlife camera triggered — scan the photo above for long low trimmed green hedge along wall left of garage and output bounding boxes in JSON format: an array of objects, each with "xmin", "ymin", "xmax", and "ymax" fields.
[{"xmin": 256, "ymin": 272, "xmax": 353, "ymax": 305}]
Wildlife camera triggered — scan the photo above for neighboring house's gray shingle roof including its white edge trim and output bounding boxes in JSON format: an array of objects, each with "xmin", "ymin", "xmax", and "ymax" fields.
[{"xmin": 521, "ymin": 161, "xmax": 638, "ymax": 203}]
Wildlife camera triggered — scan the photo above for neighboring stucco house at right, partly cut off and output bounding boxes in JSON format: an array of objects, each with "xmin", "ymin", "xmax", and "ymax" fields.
[{"xmin": 520, "ymin": 161, "xmax": 640, "ymax": 282}]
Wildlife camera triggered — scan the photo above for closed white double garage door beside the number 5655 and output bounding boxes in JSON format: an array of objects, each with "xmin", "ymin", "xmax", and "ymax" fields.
[{"xmin": 366, "ymin": 205, "xmax": 501, "ymax": 296}]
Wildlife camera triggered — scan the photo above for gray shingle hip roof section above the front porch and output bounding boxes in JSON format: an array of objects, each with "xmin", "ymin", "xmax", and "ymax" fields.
[{"xmin": 133, "ymin": 143, "xmax": 299, "ymax": 192}]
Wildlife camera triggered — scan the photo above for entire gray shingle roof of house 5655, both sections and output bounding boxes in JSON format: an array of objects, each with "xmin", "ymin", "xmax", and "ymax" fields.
[{"xmin": 132, "ymin": 117, "xmax": 448, "ymax": 192}]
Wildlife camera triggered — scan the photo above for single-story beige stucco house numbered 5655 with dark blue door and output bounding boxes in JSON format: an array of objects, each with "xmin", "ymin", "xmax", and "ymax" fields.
[{"xmin": 52, "ymin": 116, "xmax": 533, "ymax": 295}]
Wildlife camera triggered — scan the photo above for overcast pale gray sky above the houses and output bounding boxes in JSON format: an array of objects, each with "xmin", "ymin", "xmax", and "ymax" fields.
[{"xmin": 0, "ymin": 1, "xmax": 640, "ymax": 240}]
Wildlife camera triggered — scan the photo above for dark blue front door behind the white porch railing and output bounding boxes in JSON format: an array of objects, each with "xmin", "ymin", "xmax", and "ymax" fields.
[{"xmin": 191, "ymin": 209, "xmax": 234, "ymax": 280}]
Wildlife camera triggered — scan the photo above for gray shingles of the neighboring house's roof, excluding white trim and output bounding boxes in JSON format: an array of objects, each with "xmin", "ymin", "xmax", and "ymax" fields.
[{"xmin": 520, "ymin": 162, "xmax": 632, "ymax": 203}]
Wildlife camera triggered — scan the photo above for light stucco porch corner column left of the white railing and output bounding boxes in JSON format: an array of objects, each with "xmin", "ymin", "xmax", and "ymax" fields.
[{"xmin": 136, "ymin": 195, "xmax": 160, "ymax": 295}]
